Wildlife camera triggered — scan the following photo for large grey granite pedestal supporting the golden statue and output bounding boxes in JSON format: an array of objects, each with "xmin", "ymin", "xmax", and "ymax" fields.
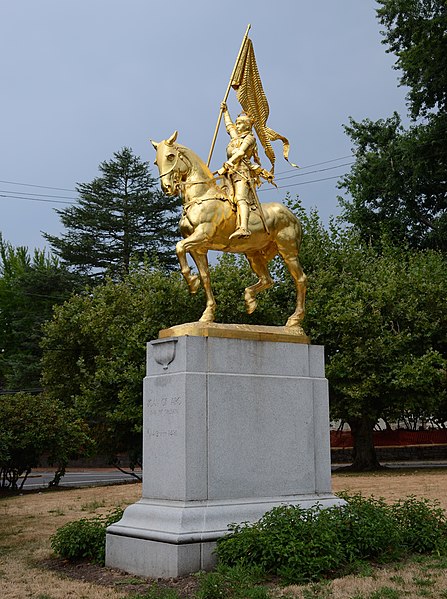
[{"xmin": 106, "ymin": 328, "xmax": 341, "ymax": 578}]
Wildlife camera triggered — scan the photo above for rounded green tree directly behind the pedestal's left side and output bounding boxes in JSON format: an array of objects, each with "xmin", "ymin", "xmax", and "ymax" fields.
[{"xmin": 42, "ymin": 265, "xmax": 201, "ymax": 465}]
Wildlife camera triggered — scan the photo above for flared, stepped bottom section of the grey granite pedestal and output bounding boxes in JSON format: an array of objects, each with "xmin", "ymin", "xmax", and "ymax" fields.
[{"xmin": 106, "ymin": 494, "xmax": 344, "ymax": 578}]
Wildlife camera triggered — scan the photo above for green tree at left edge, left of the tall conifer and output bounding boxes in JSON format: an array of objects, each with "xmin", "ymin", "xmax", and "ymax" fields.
[{"xmin": 0, "ymin": 237, "xmax": 82, "ymax": 392}]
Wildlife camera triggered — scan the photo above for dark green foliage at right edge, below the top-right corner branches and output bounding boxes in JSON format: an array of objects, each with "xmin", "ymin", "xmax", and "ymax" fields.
[{"xmin": 339, "ymin": 113, "xmax": 447, "ymax": 251}]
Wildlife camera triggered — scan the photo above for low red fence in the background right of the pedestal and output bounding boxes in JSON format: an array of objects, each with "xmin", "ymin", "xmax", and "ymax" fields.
[{"xmin": 331, "ymin": 429, "xmax": 447, "ymax": 448}]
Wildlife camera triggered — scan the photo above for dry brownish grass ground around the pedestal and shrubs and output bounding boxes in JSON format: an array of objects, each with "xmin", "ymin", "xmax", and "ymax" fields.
[{"xmin": 0, "ymin": 469, "xmax": 447, "ymax": 599}]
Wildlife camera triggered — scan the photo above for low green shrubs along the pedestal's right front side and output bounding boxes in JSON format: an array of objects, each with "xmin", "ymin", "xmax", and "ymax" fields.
[{"xmin": 217, "ymin": 494, "xmax": 447, "ymax": 583}]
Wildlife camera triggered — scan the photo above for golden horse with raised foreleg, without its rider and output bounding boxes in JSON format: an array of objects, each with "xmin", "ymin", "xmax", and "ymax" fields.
[{"xmin": 152, "ymin": 131, "xmax": 306, "ymax": 335}]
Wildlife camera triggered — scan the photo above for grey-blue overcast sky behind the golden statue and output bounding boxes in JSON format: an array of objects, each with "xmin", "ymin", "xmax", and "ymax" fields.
[{"xmin": 0, "ymin": 0, "xmax": 406, "ymax": 253}]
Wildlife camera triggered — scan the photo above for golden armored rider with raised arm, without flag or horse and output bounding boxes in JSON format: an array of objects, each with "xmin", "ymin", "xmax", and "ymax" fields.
[{"xmin": 218, "ymin": 102, "xmax": 263, "ymax": 239}]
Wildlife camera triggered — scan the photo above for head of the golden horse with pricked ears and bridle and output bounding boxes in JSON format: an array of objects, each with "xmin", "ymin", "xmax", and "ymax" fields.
[{"xmin": 151, "ymin": 131, "xmax": 189, "ymax": 196}]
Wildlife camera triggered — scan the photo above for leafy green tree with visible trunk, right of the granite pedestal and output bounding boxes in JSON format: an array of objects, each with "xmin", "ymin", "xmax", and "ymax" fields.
[{"xmin": 303, "ymin": 210, "xmax": 447, "ymax": 470}]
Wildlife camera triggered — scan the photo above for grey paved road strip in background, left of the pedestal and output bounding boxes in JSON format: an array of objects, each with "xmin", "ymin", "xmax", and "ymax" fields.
[{"xmin": 23, "ymin": 469, "xmax": 141, "ymax": 490}]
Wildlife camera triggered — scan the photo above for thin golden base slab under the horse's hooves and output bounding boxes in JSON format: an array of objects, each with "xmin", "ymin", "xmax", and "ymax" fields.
[{"xmin": 158, "ymin": 322, "xmax": 310, "ymax": 344}]
